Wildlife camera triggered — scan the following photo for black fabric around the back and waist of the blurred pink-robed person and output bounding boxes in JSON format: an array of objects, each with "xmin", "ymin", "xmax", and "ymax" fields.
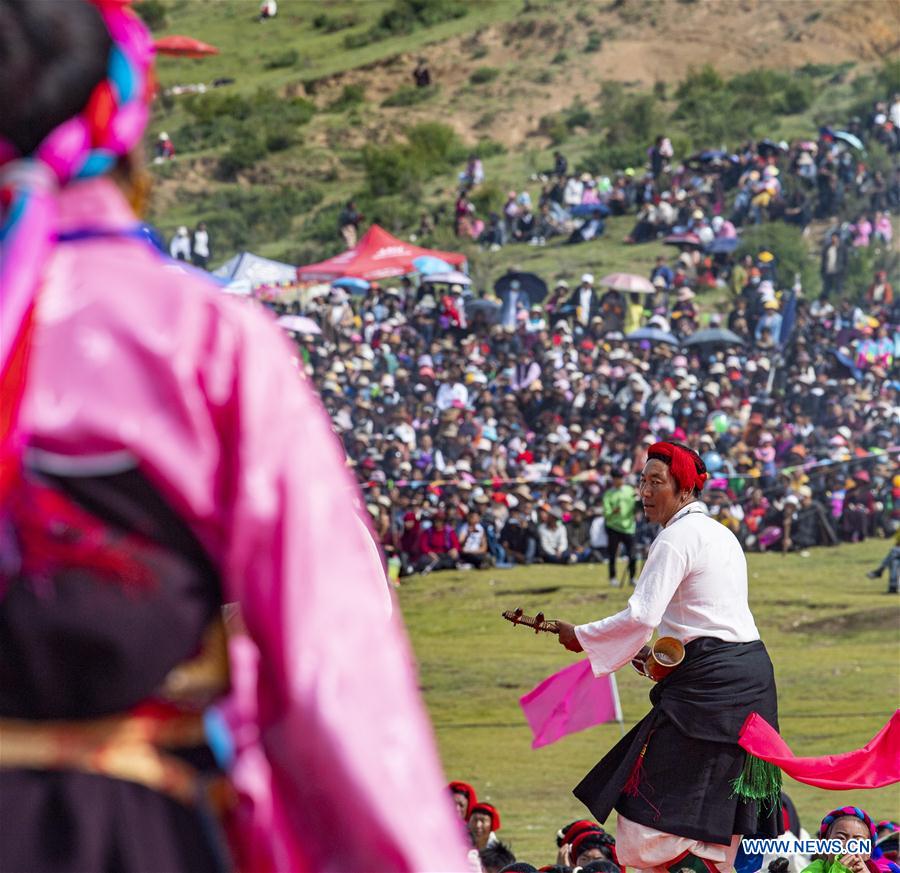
[{"xmin": 0, "ymin": 470, "xmax": 230, "ymax": 873}]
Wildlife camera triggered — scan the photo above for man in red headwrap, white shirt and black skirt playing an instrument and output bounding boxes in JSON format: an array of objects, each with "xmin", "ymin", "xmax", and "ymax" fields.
[{"xmin": 557, "ymin": 442, "xmax": 780, "ymax": 871}]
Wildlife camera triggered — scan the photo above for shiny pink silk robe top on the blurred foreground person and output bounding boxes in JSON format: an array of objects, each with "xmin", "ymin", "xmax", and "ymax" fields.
[{"xmin": 21, "ymin": 179, "xmax": 467, "ymax": 873}]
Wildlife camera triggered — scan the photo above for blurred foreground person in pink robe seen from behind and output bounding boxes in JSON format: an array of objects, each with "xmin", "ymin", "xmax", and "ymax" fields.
[{"xmin": 0, "ymin": 0, "xmax": 466, "ymax": 873}]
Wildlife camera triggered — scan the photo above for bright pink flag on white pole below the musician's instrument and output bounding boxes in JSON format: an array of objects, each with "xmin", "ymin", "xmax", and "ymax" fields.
[{"xmin": 519, "ymin": 659, "xmax": 622, "ymax": 749}]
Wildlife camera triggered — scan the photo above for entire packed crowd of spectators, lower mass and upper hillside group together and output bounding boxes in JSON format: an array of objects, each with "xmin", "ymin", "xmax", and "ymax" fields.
[{"xmin": 241, "ymin": 87, "xmax": 900, "ymax": 590}]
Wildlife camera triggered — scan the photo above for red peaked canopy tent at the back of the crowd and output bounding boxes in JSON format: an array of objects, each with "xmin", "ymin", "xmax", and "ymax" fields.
[{"xmin": 297, "ymin": 224, "xmax": 466, "ymax": 282}]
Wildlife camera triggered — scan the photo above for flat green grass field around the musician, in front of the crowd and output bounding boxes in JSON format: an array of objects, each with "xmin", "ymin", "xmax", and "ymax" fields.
[{"xmin": 399, "ymin": 540, "xmax": 900, "ymax": 866}]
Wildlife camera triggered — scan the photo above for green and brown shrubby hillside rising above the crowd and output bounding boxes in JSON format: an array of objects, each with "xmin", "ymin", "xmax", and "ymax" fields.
[{"xmin": 139, "ymin": 0, "xmax": 900, "ymax": 283}]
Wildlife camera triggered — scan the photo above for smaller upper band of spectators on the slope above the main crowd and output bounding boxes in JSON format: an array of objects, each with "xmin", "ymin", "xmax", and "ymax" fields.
[{"xmin": 455, "ymin": 95, "xmax": 900, "ymax": 250}]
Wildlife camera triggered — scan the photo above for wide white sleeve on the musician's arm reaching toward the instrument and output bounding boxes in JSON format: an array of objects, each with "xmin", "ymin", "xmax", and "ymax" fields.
[{"xmin": 575, "ymin": 540, "xmax": 688, "ymax": 676}]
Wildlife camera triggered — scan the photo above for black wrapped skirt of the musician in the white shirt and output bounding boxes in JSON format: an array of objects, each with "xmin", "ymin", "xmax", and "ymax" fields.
[{"xmin": 574, "ymin": 637, "xmax": 782, "ymax": 845}]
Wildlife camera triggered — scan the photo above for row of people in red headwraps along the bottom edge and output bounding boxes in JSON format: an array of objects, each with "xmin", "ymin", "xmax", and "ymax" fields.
[{"xmin": 448, "ymin": 782, "xmax": 900, "ymax": 873}]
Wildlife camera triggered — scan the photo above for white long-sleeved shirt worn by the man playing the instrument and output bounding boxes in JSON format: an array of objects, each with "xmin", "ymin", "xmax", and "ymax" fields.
[{"xmin": 575, "ymin": 502, "xmax": 759, "ymax": 676}]
